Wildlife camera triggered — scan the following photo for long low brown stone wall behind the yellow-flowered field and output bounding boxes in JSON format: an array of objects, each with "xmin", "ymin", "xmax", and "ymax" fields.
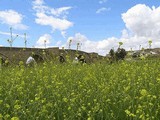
[{"xmin": 0, "ymin": 47, "xmax": 104, "ymax": 64}]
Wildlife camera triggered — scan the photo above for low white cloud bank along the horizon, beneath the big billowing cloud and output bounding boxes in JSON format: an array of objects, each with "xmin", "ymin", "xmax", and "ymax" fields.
[{"xmin": 63, "ymin": 31, "xmax": 160, "ymax": 55}]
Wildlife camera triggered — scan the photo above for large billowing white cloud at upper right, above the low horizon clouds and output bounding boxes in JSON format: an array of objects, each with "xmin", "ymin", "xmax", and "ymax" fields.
[{"xmin": 122, "ymin": 4, "xmax": 160, "ymax": 38}]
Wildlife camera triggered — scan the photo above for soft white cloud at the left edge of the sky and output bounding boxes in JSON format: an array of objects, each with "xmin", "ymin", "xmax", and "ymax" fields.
[{"xmin": 0, "ymin": 10, "xmax": 28, "ymax": 30}]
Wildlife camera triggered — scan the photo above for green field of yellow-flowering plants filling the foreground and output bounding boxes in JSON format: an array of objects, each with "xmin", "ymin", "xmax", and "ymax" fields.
[{"xmin": 0, "ymin": 59, "xmax": 160, "ymax": 120}]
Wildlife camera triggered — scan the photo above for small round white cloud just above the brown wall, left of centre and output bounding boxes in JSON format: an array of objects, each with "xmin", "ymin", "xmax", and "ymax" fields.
[{"xmin": 36, "ymin": 34, "xmax": 52, "ymax": 48}]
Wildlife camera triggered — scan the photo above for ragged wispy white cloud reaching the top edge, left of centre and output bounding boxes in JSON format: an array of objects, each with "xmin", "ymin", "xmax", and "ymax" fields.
[{"xmin": 33, "ymin": 0, "xmax": 73, "ymax": 36}]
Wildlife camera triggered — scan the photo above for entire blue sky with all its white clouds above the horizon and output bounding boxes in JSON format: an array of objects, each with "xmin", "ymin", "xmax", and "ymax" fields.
[{"xmin": 0, "ymin": 0, "xmax": 160, "ymax": 55}]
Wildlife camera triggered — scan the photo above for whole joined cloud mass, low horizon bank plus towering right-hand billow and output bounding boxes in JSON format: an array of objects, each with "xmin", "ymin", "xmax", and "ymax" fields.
[{"xmin": 40, "ymin": 4, "xmax": 160, "ymax": 55}]
